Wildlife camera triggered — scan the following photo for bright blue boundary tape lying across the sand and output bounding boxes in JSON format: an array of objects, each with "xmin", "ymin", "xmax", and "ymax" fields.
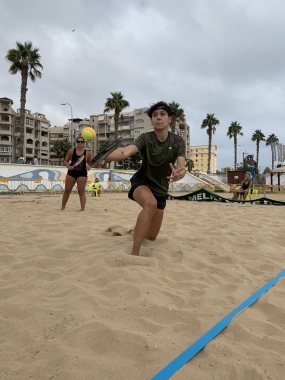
[{"xmin": 151, "ymin": 270, "xmax": 285, "ymax": 380}]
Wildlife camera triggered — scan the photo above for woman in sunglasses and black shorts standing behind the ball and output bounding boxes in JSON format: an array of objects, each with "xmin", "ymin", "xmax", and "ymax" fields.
[{"xmin": 61, "ymin": 137, "xmax": 91, "ymax": 211}]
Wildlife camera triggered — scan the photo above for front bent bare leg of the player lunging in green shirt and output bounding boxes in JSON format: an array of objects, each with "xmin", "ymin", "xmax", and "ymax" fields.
[{"xmin": 131, "ymin": 186, "xmax": 158, "ymax": 256}]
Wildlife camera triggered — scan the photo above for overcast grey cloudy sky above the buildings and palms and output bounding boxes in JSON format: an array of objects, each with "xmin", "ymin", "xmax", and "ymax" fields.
[{"xmin": 0, "ymin": 0, "xmax": 285, "ymax": 169}]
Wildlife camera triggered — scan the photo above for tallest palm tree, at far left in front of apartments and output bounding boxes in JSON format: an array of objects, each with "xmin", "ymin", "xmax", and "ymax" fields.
[{"xmin": 5, "ymin": 41, "xmax": 43, "ymax": 155}]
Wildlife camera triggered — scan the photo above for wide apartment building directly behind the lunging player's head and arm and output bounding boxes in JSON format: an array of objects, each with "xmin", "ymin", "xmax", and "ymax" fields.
[{"xmin": 89, "ymin": 108, "xmax": 190, "ymax": 158}]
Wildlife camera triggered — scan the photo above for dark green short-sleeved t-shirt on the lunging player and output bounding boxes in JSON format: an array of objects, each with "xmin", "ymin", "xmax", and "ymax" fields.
[{"xmin": 131, "ymin": 132, "xmax": 185, "ymax": 196}]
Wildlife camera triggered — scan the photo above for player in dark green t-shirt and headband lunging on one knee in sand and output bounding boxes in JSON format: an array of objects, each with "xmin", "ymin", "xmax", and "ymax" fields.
[{"xmin": 106, "ymin": 102, "xmax": 185, "ymax": 255}]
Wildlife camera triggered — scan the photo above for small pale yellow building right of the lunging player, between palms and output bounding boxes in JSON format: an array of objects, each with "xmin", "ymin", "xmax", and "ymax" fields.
[{"xmin": 190, "ymin": 145, "xmax": 218, "ymax": 174}]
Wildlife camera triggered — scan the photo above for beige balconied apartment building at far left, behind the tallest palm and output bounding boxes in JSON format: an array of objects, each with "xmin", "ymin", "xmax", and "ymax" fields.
[{"xmin": 0, "ymin": 98, "xmax": 50, "ymax": 165}]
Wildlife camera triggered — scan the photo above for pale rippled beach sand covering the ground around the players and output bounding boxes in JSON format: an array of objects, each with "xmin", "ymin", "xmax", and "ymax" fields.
[{"xmin": 0, "ymin": 193, "xmax": 285, "ymax": 380}]
